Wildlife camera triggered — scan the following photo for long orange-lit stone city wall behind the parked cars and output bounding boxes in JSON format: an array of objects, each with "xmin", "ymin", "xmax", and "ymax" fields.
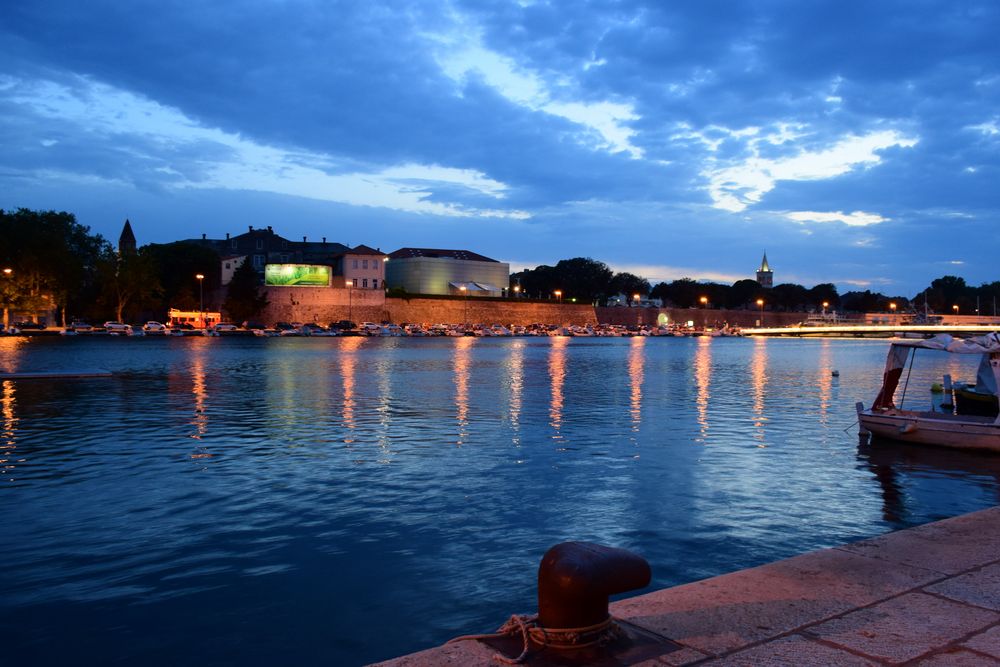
[{"xmin": 259, "ymin": 287, "xmax": 806, "ymax": 328}]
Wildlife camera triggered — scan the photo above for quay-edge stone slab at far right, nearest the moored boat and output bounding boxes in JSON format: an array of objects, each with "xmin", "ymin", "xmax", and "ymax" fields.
[{"xmin": 838, "ymin": 507, "xmax": 1000, "ymax": 574}]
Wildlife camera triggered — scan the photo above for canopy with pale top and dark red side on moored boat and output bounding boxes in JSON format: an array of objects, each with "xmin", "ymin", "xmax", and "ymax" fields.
[{"xmin": 872, "ymin": 333, "xmax": 1000, "ymax": 412}]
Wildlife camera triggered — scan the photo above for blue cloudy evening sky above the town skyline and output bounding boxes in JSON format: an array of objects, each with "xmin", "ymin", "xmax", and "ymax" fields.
[{"xmin": 0, "ymin": 0, "xmax": 1000, "ymax": 296}]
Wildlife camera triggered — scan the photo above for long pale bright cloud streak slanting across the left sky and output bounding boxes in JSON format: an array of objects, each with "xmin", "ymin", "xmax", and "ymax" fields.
[{"xmin": 0, "ymin": 76, "xmax": 530, "ymax": 219}]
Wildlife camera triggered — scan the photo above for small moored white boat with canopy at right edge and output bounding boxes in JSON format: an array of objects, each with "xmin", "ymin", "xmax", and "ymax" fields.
[{"xmin": 855, "ymin": 333, "xmax": 1000, "ymax": 452}]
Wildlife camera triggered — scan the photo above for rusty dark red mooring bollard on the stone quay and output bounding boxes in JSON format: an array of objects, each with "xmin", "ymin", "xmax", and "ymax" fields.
[{"xmin": 538, "ymin": 542, "xmax": 652, "ymax": 630}]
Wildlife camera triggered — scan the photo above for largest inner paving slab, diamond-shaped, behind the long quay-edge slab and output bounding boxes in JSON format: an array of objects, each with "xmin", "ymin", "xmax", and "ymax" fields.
[{"xmin": 806, "ymin": 592, "xmax": 1000, "ymax": 664}]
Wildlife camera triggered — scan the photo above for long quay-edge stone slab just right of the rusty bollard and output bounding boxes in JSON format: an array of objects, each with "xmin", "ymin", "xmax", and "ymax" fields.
[{"xmin": 611, "ymin": 549, "xmax": 940, "ymax": 655}]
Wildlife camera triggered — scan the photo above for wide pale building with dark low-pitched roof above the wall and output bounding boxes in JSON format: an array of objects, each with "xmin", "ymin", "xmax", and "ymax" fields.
[{"xmin": 385, "ymin": 248, "xmax": 510, "ymax": 296}]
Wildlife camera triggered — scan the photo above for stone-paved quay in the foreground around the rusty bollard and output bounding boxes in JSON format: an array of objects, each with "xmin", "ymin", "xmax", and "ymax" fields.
[{"xmin": 382, "ymin": 507, "xmax": 1000, "ymax": 667}]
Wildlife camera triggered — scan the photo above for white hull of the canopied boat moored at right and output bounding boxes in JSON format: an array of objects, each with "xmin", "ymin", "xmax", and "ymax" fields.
[{"xmin": 858, "ymin": 410, "xmax": 1000, "ymax": 452}]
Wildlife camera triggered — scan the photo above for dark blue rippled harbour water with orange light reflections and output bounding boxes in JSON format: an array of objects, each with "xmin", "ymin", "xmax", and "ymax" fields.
[{"xmin": 0, "ymin": 337, "xmax": 1000, "ymax": 664}]
